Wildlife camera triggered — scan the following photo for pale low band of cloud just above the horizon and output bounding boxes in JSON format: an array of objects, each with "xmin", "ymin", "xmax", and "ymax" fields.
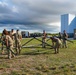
[{"xmin": 0, "ymin": 24, "xmax": 60, "ymax": 33}]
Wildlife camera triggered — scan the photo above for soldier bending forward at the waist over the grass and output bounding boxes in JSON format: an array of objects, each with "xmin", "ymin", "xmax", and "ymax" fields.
[{"xmin": 50, "ymin": 37, "xmax": 62, "ymax": 54}]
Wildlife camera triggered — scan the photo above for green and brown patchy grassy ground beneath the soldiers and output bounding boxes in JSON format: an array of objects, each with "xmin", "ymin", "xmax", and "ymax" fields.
[{"xmin": 0, "ymin": 39, "xmax": 76, "ymax": 75}]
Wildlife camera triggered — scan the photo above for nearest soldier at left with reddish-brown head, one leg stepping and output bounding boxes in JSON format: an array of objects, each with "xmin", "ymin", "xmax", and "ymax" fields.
[{"xmin": 4, "ymin": 30, "xmax": 15, "ymax": 59}]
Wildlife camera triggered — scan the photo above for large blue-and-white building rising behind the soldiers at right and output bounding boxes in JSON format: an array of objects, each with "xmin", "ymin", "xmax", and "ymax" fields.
[{"xmin": 61, "ymin": 14, "xmax": 76, "ymax": 33}]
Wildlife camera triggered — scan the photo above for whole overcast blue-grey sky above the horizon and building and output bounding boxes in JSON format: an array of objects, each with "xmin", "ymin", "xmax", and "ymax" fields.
[{"xmin": 0, "ymin": 0, "xmax": 76, "ymax": 32}]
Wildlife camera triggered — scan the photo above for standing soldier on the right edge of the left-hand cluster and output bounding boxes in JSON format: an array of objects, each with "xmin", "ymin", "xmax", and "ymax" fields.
[{"xmin": 15, "ymin": 29, "xmax": 22, "ymax": 54}]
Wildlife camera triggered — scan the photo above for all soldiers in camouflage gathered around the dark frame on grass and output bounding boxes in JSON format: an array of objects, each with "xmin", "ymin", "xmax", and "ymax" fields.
[{"xmin": 1, "ymin": 29, "xmax": 68, "ymax": 59}]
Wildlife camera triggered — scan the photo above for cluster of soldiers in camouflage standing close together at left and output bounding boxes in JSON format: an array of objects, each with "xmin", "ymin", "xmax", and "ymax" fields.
[{"xmin": 1, "ymin": 29, "xmax": 22, "ymax": 59}]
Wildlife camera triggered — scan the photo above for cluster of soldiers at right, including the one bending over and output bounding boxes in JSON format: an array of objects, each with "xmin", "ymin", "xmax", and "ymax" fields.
[{"xmin": 42, "ymin": 30, "xmax": 68, "ymax": 54}]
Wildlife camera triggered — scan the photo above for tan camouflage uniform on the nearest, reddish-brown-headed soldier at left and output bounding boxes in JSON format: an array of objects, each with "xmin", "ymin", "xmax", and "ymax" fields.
[{"xmin": 5, "ymin": 35, "xmax": 15, "ymax": 59}]
